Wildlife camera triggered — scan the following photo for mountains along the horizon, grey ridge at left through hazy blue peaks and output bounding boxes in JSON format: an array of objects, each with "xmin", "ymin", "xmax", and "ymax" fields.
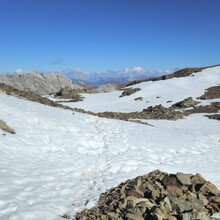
[{"xmin": 0, "ymin": 66, "xmax": 219, "ymax": 95}]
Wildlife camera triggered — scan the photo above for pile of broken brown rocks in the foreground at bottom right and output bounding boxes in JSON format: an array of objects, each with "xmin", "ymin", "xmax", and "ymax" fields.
[{"xmin": 75, "ymin": 170, "xmax": 220, "ymax": 220}]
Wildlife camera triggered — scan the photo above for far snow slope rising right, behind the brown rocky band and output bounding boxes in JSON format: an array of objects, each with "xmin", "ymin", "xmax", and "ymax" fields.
[{"xmin": 60, "ymin": 67, "xmax": 220, "ymax": 112}]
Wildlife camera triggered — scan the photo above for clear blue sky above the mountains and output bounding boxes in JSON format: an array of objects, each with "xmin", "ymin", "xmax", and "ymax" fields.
[{"xmin": 0, "ymin": 0, "xmax": 220, "ymax": 73}]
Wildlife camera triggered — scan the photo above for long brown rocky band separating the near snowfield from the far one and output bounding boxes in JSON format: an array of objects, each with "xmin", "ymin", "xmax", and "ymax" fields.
[{"xmin": 0, "ymin": 83, "xmax": 220, "ymax": 124}]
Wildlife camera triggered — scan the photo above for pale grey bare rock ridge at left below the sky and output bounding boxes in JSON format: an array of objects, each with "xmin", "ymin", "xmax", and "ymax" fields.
[{"xmin": 0, "ymin": 73, "xmax": 87, "ymax": 95}]
